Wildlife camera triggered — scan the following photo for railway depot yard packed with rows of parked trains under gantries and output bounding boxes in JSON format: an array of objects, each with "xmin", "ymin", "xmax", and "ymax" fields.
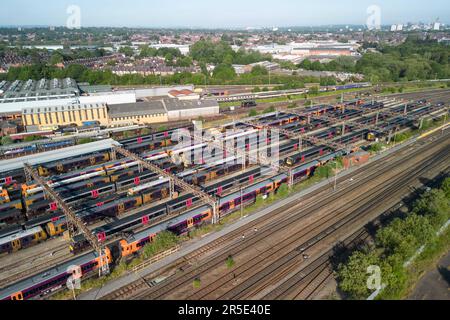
[{"xmin": 0, "ymin": 87, "xmax": 449, "ymax": 300}]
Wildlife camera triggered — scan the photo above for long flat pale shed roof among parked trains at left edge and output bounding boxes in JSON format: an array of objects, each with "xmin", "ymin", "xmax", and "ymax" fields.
[{"xmin": 0, "ymin": 139, "xmax": 120, "ymax": 172}]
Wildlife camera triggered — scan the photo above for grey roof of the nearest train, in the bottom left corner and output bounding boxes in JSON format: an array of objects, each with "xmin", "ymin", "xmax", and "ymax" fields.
[{"xmin": 0, "ymin": 252, "xmax": 98, "ymax": 300}]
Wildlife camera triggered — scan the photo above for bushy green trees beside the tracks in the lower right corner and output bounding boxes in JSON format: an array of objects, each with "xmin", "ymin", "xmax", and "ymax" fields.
[{"xmin": 337, "ymin": 178, "xmax": 450, "ymax": 299}]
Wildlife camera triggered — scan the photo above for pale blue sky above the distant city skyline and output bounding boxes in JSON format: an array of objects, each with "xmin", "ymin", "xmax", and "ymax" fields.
[{"xmin": 0, "ymin": 0, "xmax": 450, "ymax": 28}]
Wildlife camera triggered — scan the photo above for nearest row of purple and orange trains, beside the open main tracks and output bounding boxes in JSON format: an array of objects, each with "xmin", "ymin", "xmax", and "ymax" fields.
[{"xmin": 0, "ymin": 151, "xmax": 338, "ymax": 300}]
